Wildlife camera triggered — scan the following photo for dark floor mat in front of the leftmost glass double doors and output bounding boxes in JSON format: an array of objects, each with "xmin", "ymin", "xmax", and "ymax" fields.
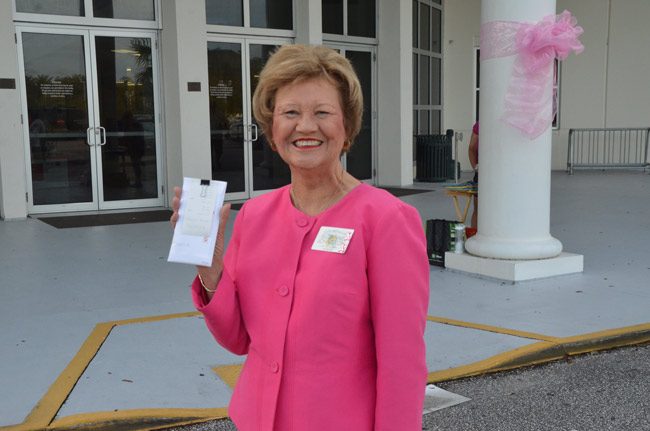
[{"xmin": 38, "ymin": 210, "xmax": 172, "ymax": 229}]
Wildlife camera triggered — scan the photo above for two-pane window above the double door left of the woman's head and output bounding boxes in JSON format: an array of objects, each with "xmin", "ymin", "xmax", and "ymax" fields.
[{"xmin": 205, "ymin": 0, "xmax": 293, "ymax": 30}]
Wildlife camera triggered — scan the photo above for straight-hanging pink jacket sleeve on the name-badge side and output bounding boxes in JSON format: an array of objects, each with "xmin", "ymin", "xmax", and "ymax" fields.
[{"xmin": 368, "ymin": 203, "xmax": 429, "ymax": 431}]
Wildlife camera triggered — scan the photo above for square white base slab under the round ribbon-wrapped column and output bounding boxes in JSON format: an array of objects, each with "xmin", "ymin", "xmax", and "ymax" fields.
[{"xmin": 445, "ymin": 252, "xmax": 584, "ymax": 282}]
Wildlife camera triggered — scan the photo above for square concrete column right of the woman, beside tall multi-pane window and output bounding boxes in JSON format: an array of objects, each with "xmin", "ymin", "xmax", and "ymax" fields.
[{"xmin": 377, "ymin": 0, "xmax": 413, "ymax": 186}]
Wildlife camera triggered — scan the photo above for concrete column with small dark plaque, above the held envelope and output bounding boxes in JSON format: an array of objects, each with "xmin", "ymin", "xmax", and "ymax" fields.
[{"xmin": 160, "ymin": 0, "xmax": 212, "ymax": 206}]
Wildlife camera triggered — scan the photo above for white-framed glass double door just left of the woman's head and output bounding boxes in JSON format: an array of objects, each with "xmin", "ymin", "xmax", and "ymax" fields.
[{"xmin": 208, "ymin": 37, "xmax": 290, "ymax": 200}]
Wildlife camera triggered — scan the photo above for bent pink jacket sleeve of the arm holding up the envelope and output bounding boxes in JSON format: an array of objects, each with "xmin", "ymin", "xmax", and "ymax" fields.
[{"xmin": 191, "ymin": 206, "xmax": 250, "ymax": 355}]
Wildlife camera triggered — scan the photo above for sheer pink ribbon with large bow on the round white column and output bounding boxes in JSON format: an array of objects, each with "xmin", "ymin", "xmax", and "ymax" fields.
[{"xmin": 481, "ymin": 10, "xmax": 584, "ymax": 139}]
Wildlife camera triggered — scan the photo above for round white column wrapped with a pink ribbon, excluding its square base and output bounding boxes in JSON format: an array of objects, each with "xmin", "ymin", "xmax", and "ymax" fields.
[{"xmin": 466, "ymin": 0, "xmax": 562, "ymax": 259}]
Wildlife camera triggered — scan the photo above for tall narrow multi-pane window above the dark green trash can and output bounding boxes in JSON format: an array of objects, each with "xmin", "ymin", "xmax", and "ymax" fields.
[{"xmin": 413, "ymin": 0, "xmax": 442, "ymax": 135}]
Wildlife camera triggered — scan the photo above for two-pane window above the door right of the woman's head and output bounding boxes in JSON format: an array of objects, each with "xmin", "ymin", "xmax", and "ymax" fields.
[{"xmin": 321, "ymin": 0, "xmax": 377, "ymax": 38}]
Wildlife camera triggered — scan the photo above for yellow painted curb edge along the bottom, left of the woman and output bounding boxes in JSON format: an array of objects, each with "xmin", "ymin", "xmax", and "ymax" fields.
[{"xmin": 47, "ymin": 407, "xmax": 228, "ymax": 431}]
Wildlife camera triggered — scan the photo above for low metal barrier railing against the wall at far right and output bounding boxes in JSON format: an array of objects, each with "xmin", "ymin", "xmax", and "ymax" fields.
[{"xmin": 567, "ymin": 128, "xmax": 650, "ymax": 174}]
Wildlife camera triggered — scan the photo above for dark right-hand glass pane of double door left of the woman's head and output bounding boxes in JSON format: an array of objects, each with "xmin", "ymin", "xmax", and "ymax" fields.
[{"xmin": 250, "ymin": 45, "xmax": 291, "ymax": 190}]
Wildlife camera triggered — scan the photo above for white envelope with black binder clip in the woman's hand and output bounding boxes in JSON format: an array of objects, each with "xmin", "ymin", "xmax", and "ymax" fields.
[{"xmin": 167, "ymin": 177, "xmax": 226, "ymax": 266}]
